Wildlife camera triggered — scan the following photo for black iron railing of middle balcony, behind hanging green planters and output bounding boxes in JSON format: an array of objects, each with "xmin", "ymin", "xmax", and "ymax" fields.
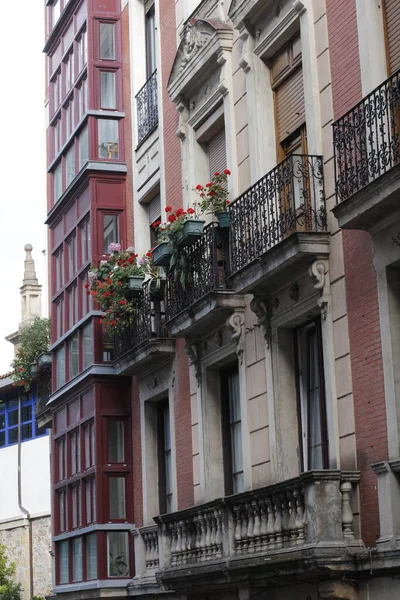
[{"xmin": 167, "ymin": 223, "xmax": 227, "ymax": 320}]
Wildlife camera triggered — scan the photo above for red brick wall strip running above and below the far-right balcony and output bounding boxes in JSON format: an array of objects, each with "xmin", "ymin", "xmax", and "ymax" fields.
[{"xmin": 326, "ymin": 0, "xmax": 388, "ymax": 546}]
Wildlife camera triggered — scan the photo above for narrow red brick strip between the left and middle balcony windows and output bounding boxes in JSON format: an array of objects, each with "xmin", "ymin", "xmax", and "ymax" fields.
[{"xmin": 160, "ymin": 0, "xmax": 194, "ymax": 510}]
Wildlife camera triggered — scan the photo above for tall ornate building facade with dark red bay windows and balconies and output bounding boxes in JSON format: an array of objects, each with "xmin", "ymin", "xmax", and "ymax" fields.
[{"xmin": 45, "ymin": 0, "xmax": 400, "ymax": 600}]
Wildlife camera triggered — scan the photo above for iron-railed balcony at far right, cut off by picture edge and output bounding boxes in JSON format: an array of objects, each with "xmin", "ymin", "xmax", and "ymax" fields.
[{"xmin": 333, "ymin": 70, "xmax": 400, "ymax": 230}]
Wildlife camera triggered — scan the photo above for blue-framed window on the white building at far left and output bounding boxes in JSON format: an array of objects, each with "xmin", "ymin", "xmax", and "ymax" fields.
[{"xmin": 0, "ymin": 394, "xmax": 47, "ymax": 448}]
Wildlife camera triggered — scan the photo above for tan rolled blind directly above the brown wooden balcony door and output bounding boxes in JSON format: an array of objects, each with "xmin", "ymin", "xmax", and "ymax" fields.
[{"xmin": 275, "ymin": 67, "xmax": 306, "ymax": 143}]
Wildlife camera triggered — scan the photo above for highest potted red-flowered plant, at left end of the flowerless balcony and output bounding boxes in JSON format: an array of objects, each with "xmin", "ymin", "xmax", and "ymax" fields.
[{"xmin": 196, "ymin": 169, "xmax": 231, "ymax": 229}]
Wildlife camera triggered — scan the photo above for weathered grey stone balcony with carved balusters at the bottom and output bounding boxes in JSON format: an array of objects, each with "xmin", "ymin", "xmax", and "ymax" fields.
[{"xmin": 152, "ymin": 471, "xmax": 360, "ymax": 593}]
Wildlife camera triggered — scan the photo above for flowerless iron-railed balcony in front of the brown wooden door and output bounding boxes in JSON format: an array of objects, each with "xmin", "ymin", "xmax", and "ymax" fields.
[{"xmin": 229, "ymin": 155, "xmax": 330, "ymax": 295}]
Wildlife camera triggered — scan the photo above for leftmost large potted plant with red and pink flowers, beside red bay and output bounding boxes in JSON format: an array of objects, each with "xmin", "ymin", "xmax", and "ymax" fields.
[{"xmin": 85, "ymin": 243, "xmax": 145, "ymax": 335}]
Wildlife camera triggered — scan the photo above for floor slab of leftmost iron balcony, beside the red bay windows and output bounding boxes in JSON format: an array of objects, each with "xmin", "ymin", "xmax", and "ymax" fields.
[{"xmin": 114, "ymin": 338, "xmax": 175, "ymax": 375}]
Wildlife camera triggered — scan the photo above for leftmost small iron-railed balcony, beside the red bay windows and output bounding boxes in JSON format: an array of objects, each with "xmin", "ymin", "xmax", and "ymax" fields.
[{"xmin": 114, "ymin": 282, "xmax": 175, "ymax": 375}]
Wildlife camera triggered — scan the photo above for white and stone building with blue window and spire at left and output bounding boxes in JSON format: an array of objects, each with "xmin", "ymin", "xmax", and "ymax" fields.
[{"xmin": 0, "ymin": 244, "xmax": 52, "ymax": 600}]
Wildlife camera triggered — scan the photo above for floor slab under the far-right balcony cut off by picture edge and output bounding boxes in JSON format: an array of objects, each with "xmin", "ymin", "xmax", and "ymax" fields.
[{"xmin": 332, "ymin": 164, "xmax": 400, "ymax": 230}]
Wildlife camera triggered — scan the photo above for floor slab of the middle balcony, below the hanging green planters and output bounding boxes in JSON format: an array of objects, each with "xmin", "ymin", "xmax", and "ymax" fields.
[{"xmin": 167, "ymin": 290, "xmax": 245, "ymax": 337}]
